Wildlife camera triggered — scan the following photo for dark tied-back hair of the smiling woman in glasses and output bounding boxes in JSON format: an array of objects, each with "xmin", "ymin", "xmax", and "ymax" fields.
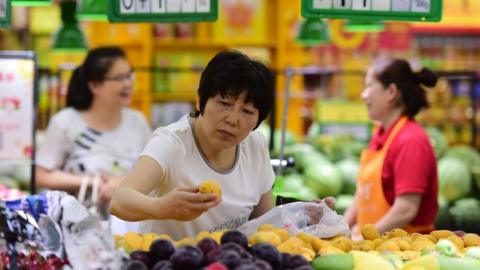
[{"xmin": 67, "ymin": 47, "xmax": 126, "ymax": 111}]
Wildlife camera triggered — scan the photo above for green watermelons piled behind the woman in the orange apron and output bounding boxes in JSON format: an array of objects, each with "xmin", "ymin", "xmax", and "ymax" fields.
[{"xmin": 264, "ymin": 123, "xmax": 480, "ymax": 232}]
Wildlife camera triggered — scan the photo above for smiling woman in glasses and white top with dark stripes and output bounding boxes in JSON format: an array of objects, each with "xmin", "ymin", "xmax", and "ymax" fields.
[{"xmin": 36, "ymin": 47, "xmax": 151, "ymax": 207}]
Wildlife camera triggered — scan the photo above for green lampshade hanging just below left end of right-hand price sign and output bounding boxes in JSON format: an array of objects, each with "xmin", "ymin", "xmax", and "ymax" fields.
[{"xmin": 296, "ymin": 18, "xmax": 330, "ymax": 46}]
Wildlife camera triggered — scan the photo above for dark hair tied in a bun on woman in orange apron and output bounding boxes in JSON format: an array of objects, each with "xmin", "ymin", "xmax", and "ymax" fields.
[{"xmin": 373, "ymin": 59, "xmax": 438, "ymax": 119}]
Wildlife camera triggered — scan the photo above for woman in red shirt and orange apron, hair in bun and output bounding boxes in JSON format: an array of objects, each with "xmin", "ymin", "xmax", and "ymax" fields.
[{"xmin": 345, "ymin": 59, "xmax": 438, "ymax": 236}]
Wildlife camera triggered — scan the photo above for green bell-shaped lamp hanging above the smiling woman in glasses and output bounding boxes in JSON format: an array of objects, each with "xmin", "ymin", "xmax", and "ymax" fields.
[{"xmin": 52, "ymin": 1, "xmax": 87, "ymax": 51}]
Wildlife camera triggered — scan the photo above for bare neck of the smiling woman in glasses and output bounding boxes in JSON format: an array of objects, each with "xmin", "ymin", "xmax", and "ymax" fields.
[{"xmin": 82, "ymin": 102, "xmax": 122, "ymax": 131}]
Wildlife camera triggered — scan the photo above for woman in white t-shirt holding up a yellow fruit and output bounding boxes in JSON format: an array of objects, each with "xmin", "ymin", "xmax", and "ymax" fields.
[{"xmin": 110, "ymin": 50, "xmax": 275, "ymax": 239}]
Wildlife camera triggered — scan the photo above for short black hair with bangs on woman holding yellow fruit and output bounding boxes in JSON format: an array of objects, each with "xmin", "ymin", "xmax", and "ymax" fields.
[{"xmin": 195, "ymin": 50, "xmax": 275, "ymax": 128}]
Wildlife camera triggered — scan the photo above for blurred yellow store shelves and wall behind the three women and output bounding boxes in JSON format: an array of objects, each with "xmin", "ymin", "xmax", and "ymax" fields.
[{"xmin": 0, "ymin": 0, "xmax": 480, "ymax": 171}]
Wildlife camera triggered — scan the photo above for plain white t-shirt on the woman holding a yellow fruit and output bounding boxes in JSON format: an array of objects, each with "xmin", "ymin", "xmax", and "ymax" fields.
[{"xmin": 139, "ymin": 116, "xmax": 275, "ymax": 240}]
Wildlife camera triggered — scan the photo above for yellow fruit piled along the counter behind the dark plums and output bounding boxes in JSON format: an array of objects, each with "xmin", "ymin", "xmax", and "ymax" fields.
[{"xmin": 115, "ymin": 224, "xmax": 480, "ymax": 261}]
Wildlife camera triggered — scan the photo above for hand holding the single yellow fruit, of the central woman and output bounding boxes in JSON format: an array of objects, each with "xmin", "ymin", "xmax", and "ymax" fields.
[{"xmin": 158, "ymin": 187, "xmax": 221, "ymax": 221}]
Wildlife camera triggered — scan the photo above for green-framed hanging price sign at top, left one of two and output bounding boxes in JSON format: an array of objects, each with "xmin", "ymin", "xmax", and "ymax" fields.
[{"xmin": 108, "ymin": 0, "xmax": 218, "ymax": 22}]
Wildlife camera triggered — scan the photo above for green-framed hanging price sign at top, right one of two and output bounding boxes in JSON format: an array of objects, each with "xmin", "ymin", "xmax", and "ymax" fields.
[{"xmin": 302, "ymin": 0, "xmax": 443, "ymax": 22}]
